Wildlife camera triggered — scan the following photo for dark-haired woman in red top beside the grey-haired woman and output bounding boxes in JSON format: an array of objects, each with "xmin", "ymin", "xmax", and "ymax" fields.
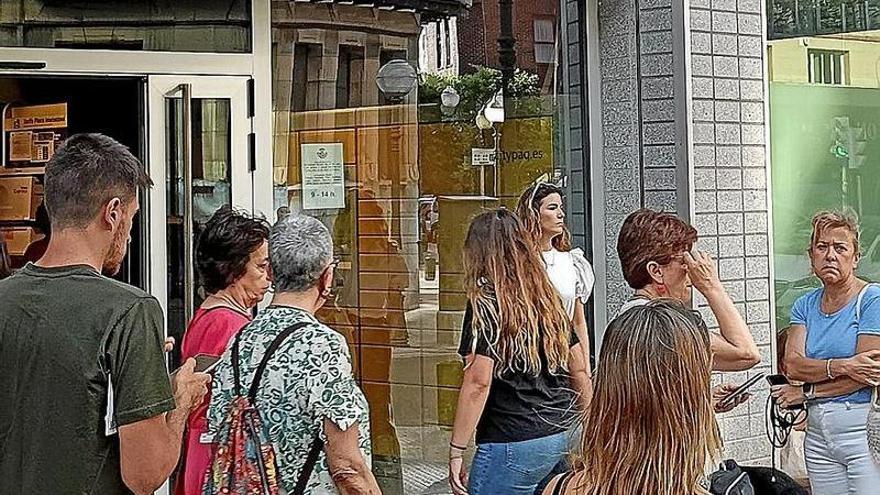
[{"xmin": 175, "ymin": 207, "xmax": 270, "ymax": 495}]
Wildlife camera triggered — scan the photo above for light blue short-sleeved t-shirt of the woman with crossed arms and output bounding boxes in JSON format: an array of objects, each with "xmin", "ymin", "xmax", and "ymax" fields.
[{"xmin": 791, "ymin": 285, "xmax": 880, "ymax": 404}]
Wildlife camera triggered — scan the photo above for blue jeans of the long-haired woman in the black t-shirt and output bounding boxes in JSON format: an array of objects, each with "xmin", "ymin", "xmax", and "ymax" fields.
[{"xmin": 468, "ymin": 432, "xmax": 570, "ymax": 495}]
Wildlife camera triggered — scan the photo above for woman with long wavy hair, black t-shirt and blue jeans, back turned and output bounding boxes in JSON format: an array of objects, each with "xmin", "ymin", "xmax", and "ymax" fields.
[{"xmin": 449, "ymin": 209, "xmax": 589, "ymax": 495}]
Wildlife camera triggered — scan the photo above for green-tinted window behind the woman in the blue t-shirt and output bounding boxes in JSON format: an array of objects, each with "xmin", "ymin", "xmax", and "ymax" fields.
[{"xmin": 768, "ymin": 31, "xmax": 880, "ymax": 330}]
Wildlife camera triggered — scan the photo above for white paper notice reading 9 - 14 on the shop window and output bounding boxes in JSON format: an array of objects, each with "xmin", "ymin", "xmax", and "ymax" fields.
[{"xmin": 300, "ymin": 143, "xmax": 345, "ymax": 210}]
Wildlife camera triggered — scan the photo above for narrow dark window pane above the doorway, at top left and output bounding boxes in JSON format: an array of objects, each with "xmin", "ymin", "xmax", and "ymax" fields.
[{"xmin": 0, "ymin": 0, "xmax": 251, "ymax": 53}]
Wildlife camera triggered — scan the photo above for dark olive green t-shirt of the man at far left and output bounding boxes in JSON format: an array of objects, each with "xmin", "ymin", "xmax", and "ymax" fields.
[{"xmin": 0, "ymin": 265, "xmax": 174, "ymax": 495}]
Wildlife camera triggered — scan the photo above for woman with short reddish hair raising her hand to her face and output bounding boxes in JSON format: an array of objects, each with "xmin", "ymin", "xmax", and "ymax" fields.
[{"xmin": 617, "ymin": 209, "xmax": 761, "ymax": 376}]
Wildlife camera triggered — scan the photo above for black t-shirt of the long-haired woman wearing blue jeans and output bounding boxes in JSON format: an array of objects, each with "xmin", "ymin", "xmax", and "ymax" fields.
[{"xmin": 458, "ymin": 303, "xmax": 579, "ymax": 444}]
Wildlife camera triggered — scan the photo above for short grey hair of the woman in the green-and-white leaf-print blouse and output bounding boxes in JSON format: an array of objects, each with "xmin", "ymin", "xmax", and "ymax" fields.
[{"xmin": 269, "ymin": 215, "xmax": 333, "ymax": 292}]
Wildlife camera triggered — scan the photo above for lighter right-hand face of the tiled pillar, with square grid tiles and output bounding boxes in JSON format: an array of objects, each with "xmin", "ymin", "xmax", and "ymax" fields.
[{"xmin": 689, "ymin": 0, "xmax": 774, "ymax": 460}]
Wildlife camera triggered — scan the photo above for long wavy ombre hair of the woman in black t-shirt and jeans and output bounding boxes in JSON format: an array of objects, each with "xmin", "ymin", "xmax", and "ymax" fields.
[{"xmin": 464, "ymin": 209, "xmax": 571, "ymax": 376}]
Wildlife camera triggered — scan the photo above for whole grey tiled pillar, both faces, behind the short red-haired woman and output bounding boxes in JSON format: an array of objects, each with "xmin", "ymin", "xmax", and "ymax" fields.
[{"xmin": 573, "ymin": 0, "xmax": 775, "ymax": 462}]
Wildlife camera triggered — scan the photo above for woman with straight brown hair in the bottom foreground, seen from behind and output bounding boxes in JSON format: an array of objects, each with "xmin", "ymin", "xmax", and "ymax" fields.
[{"xmin": 544, "ymin": 299, "xmax": 721, "ymax": 495}]
